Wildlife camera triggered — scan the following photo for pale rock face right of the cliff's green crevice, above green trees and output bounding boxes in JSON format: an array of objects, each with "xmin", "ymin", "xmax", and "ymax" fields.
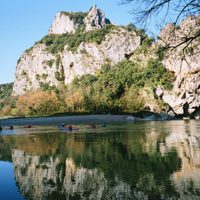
[{"xmin": 61, "ymin": 28, "xmax": 140, "ymax": 83}]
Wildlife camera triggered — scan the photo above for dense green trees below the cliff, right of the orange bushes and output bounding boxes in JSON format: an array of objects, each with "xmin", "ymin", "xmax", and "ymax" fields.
[{"xmin": 73, "ymin": 59, "xmax": 173, "ymax": 112}]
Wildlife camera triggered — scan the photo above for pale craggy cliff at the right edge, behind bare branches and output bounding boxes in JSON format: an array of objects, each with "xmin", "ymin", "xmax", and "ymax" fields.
[{"xmin": 157, "ymin": 15, "xmax": 200, "ymax": 115}]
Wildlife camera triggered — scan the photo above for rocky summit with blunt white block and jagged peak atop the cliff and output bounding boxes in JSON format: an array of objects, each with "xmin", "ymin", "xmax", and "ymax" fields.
[{"xmin": 49, "ymin": 5, "xmax": 110, "ymax": 34}]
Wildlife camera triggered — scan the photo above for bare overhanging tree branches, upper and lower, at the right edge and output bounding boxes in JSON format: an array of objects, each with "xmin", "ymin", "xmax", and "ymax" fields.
[{"xmin": 122, "ymin": 0, "xmax": 200, "ymax": 49}]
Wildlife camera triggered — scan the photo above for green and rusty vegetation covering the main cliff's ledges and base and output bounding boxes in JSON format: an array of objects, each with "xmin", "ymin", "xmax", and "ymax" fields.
[{"xmin": 0, "ymin": 19, "xmax": 174, "ymax": 116}]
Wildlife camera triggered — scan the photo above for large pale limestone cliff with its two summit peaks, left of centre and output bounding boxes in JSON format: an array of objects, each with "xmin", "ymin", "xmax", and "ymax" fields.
[{"xmin": 13, "ymin": 6, "xmax": 141, "ymax": 95}]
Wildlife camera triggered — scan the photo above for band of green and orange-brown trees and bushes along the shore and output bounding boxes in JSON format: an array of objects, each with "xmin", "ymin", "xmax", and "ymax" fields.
[{"xmin": 0, "ymin": 56, "xmax": 173, "ymax": 116}]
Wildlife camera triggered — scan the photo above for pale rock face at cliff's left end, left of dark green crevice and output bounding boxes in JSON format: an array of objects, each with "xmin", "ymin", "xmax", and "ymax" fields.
[{"xmin": 13, "ymin": 44, "xmax": 58, "ymax": 95}]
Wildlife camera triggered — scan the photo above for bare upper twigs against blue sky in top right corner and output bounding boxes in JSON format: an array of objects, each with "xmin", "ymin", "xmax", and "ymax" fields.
[{"xmin": 122, "ymin": 0, "xmax": 200, "ymax": 24}]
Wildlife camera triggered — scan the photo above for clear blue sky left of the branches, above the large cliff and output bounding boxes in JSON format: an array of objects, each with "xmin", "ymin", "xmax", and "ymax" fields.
[{"xmin": 0, "ymin": 0, "xmax": 158, "ymax": 84}]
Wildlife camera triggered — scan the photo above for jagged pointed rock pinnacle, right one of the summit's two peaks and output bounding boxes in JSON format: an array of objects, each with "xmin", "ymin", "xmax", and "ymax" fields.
[{"xmin": 85, "ymin": 5, "xmax": 110, "ymax": 31}]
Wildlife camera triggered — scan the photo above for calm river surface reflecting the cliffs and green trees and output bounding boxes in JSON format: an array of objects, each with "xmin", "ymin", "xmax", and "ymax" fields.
[{"xmin": 0, "ymin": 120, "xmax": 200, "ymax": 200}]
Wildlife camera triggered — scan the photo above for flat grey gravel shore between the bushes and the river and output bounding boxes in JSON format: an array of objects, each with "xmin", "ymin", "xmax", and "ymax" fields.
[{"xmin": 0, "ymin": 115, "xmax": 128, "ymax": 126}]
